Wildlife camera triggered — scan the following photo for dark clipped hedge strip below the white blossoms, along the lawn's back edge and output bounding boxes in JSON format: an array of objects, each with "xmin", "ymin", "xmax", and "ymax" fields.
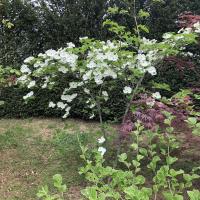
[{"xmin": 0, "ymin": 81, "xmax": 125, "ymax": 120}]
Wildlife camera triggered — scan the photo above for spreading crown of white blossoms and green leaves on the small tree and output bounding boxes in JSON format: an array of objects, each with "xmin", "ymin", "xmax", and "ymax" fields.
[{"xmin": 18, "ymin": 20, "xmax": 199, "ymax": 127}]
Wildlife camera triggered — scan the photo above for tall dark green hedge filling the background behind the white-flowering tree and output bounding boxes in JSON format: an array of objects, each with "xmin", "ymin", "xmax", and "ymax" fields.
[{"xmin": 0, "ymin": 0, "xmax": 200, "ymax": 119}]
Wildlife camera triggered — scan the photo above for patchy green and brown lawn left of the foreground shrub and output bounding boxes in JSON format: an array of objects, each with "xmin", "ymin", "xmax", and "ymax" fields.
[{"xmin": 0, "ymin": 119, "xmax": 99, "ymax": 200}]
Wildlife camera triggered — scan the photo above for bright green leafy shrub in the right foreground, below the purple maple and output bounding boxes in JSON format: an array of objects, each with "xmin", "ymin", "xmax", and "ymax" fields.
[{"xmin": 80, "ymin": 112, "xmax": 200, "ymax": 200}]
